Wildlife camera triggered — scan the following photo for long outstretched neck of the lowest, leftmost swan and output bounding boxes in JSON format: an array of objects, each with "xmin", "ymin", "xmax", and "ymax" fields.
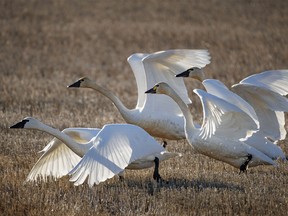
[{"xmin": 33, "ymin": 122, "xmax": 93, "ymax": 157}]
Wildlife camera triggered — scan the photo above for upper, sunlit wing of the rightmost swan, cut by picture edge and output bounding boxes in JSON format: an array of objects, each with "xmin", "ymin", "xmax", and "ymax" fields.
[{"xmin": 240, "ymin": 70, "xmax": 288, "ymax": 95}]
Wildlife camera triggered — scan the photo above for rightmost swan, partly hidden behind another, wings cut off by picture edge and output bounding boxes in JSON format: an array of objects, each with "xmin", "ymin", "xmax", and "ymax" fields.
[{"xmin": 176, "ymin": 68, "xmax": 288, "ymax": 159}]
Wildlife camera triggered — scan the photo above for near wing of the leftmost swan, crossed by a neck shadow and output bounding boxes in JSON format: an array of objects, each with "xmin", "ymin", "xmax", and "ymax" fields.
[{"xmin": 69, "ymin": 124, "xmax": 165, "ymax": 186}]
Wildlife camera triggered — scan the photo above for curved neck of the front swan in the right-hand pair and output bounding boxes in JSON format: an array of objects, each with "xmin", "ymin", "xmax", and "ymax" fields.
[{"xmin": 165, "ymin": 88, "xmax": 198, "ymax": 138}]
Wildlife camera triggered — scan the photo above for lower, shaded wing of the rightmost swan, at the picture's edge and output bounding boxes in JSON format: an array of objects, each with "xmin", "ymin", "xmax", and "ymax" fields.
[{"xmin": 232, "ymin": 83, "xmax": 288, "ymax": 140}]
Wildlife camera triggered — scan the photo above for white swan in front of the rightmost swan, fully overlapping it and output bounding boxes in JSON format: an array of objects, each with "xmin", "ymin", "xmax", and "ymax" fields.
[{"xmin": 146, "ymin": 82, "xmax": 276, "ymax": 173}]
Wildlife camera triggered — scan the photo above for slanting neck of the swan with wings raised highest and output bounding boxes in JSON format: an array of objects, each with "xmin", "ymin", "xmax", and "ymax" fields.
[{"xmin": 85, "ymin": 81, "xmax": 132, "ymax": 122}]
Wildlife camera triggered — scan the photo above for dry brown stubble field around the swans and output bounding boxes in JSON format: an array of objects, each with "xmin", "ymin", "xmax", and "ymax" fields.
[{"xmin": 0, "ymin": 0, "xmax": 288, "ymax": 215}]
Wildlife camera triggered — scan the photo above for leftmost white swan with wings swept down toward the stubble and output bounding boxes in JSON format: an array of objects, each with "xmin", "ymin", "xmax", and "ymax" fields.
[{"xmin": 10, "ymin": 117, "xmax": 181, "ymax": 187}]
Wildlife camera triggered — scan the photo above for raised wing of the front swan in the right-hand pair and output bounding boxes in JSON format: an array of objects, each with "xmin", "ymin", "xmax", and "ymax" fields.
[{"xmin": 194, "ymin": 89, "xmax": 257, "ymax": 140}]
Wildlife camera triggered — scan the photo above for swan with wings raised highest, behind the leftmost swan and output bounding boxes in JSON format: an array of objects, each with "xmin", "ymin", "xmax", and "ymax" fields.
[{"xmin": 68, "ymin": 49, "xmax": 210, "ymax": 140}]
